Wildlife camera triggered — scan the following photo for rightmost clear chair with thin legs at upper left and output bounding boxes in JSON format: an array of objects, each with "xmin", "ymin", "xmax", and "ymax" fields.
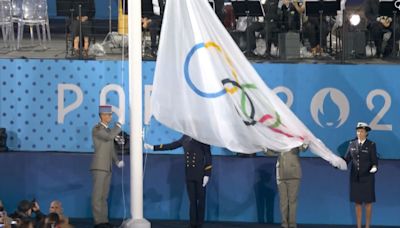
[{"xmin": 13, "ymin": 0, "xmax": 50, "ymax": 49}]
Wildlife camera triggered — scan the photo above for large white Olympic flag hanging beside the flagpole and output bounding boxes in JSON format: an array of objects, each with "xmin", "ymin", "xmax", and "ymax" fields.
[{"xmin": 151, "ymin": 0, "xmax": 346, "ymax": 169}]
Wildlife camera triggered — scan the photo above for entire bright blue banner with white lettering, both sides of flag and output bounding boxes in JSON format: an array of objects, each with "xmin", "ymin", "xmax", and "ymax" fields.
[{"xmin": 0, "ymin": 60, "xmax": 400, "ymax": 159}]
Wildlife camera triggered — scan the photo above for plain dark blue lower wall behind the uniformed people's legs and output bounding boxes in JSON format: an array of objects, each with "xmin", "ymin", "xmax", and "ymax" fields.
[{"xmin": 0, "ymin": 152, "xmax": 400, "ymax": 226}]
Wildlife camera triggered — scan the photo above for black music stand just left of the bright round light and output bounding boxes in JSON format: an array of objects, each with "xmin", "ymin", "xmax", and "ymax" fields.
[{"xmin": 306, "ymin": 0, "xmax": 340, "ymax": 54}]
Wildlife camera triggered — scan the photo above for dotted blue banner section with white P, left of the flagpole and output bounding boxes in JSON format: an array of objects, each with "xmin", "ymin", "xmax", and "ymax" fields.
[{"xmin": 0, "ymin": 60, "xmax": 128, "ymax": 151}]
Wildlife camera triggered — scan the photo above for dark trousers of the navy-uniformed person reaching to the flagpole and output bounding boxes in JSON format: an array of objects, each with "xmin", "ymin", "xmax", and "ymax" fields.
[{"xmin": 186, "ymin": 180, "xmax": 206, "ymax": 228}]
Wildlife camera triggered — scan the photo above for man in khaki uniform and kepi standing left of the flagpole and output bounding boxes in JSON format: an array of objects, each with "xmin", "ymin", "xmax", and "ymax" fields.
[{"xmin": 90, "ymin": 105, "xmax": 124, "ymax": 227}]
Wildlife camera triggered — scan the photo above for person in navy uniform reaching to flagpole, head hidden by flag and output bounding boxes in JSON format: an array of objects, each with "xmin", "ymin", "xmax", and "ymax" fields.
[{"xmin": 144, "ymin": 135, "xmax": 212, "ymax": 228}]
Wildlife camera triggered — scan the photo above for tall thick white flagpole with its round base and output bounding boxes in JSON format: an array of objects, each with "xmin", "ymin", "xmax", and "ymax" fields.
[{"xmin": 123, "ymin": 0, "xmax": 151, "ymax": 228}]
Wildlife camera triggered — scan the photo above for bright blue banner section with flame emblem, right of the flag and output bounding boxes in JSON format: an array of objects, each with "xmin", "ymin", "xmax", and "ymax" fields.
[{"xmin": 255, "ymin": 64, "xmax": 400, "ymax": 159}]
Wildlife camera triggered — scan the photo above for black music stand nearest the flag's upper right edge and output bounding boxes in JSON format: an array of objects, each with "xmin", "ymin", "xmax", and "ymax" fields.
[{"xmin": 232, "ymin": 0, "xmax": 268, "ymax": 54}]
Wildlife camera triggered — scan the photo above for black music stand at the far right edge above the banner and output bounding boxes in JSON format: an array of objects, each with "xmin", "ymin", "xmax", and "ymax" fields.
[{"xmin": 379, "ymin": 0, "xmax": 400, "ymax": 57}]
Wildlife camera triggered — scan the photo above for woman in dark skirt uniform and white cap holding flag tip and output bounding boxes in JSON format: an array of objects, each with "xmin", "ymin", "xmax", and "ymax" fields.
[{"xmin": 345, "ymin": 122, "xmax": 378, "ymax": 228}]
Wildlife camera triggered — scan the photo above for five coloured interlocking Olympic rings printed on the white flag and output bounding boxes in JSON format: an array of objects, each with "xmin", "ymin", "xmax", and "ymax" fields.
[{"xmin": 183, "ymin": 41, "xmax": 303, "ymax": 140}]
